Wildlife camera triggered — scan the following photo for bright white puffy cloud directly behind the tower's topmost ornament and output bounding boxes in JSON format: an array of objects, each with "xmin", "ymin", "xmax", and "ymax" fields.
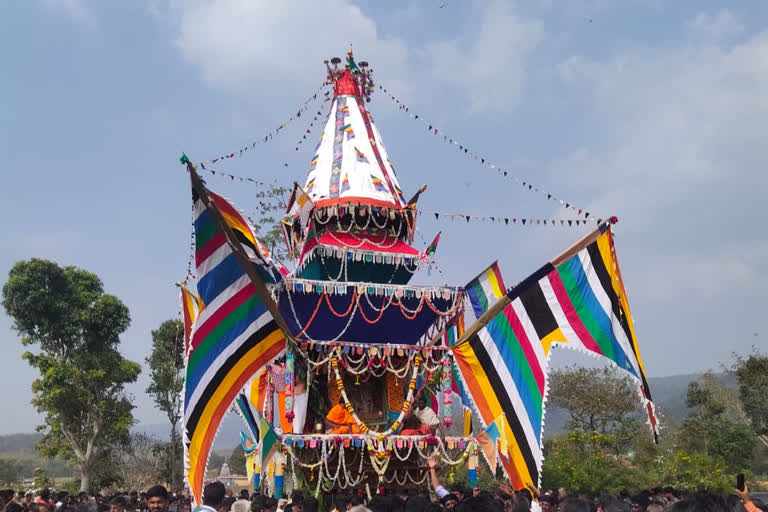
[{"xmin": 176, "ymin": 0, "xmax": 414, "ymax": 96}]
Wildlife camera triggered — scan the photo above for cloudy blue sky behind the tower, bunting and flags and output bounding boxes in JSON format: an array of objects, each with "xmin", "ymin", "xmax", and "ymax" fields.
[{"xmin": 0, "ymin": 0, "xmax": 768, "ymax": 433}]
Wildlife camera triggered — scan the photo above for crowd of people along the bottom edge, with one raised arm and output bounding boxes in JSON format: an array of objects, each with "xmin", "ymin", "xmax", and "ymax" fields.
[{"xmin": 0, "ymin": 478, "xmax": 768, "ymax": 512}]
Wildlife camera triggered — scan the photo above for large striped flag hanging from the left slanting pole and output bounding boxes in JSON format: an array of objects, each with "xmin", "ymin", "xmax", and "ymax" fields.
[{"xmin": 184, "ymin": 182, "xmax": 285, "ymax": 504}]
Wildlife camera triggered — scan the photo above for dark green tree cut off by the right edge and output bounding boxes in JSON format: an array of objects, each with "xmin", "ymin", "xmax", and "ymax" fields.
[{"xmin": 731, "ymin": 352, "xmax": 768, "ymax": 447}]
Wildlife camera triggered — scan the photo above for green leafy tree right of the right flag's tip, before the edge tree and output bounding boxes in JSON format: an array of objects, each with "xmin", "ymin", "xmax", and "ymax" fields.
[{"xmin": 682, "ymin": 374, "xmax": 755, "ymax": 473}]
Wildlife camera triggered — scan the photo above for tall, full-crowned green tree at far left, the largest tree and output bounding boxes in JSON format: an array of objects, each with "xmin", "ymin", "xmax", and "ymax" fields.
[{"xmin": 2, "ymin": 258, "xmax": 141, "ymax": 490}]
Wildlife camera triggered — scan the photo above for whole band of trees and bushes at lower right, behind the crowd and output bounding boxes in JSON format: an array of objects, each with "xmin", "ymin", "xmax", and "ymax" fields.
[{"xmin": 542, "ymin": 358, "xmax": 768, "ymax": 494}]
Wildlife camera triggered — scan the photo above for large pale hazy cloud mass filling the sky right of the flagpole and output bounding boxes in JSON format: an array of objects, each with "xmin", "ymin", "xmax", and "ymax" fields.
[{"xmin": 550, "ymin": 27, "xmax": 768, "ymax": 320}]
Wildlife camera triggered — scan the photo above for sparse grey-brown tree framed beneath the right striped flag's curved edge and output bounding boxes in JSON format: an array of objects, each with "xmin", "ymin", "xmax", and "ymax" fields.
[{"xmin": 548, "ymin": 366, "xmax": 645, "ymax": 455}]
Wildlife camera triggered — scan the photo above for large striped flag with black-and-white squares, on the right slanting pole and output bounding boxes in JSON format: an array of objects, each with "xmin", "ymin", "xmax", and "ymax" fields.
[{"xmin": 454, "ymin": 224, "xmax": 657, "ymax": 489}]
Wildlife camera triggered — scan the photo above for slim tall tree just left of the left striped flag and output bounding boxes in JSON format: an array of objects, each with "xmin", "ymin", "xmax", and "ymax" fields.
[{"xmin": 146, "ymin": 319, "xmax": 184, "ymax": 487}]
